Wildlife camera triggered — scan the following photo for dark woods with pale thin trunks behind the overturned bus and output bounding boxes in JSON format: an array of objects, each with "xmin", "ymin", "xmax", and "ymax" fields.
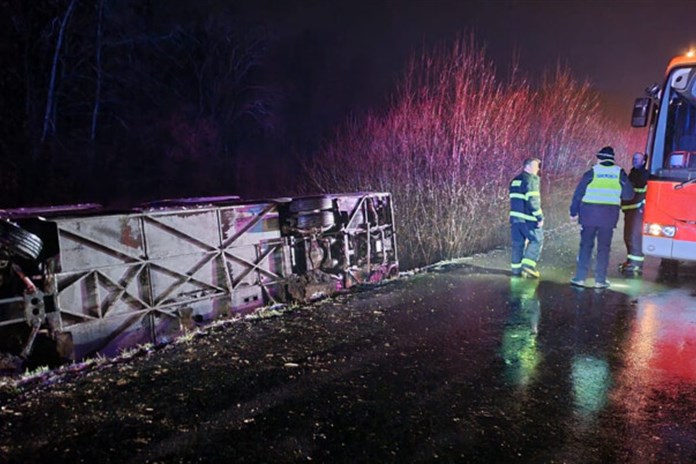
[{"xmin": 0, "ymin": 0, "xmax": 294, "ymax": 207}]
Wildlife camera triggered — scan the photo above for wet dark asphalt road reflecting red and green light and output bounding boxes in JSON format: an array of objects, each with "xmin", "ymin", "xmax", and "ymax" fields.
[{"xmin": 0, "ymin": 224, "xmax": 696, "ymax": 464}]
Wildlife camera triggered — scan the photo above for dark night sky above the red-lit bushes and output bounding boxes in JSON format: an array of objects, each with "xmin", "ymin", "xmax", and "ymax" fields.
[{"xmin": 247, "ymin": 0, "xmax": 696, "ymax": 145}]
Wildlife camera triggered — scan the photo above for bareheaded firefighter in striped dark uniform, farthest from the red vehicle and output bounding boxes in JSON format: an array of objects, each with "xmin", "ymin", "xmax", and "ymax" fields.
[{"xmin": 510, "ymin": 158, "xmax": 544, "ymax": 279}]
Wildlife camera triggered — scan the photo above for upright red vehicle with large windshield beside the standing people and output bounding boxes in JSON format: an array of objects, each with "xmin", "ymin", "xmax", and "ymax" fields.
[{"xmin": 631, "ymin": 52, "xmax": 696, "ymax": 270}]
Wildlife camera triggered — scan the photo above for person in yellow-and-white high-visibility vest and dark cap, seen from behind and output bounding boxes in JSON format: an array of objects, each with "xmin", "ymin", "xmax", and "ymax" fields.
[{"xmin": 570, "ymin": 146, "xmax": 634, "ymax": 289}]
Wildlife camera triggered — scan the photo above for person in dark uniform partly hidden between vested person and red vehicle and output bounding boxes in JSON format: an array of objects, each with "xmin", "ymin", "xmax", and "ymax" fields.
[{"xmin": 619, "ymin": 153, "xmax": 648, "ymax": 275}]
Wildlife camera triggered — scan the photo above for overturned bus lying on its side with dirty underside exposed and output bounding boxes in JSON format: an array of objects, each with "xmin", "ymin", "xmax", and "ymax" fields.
[{"xmin": 0, "ymin": 193, "xmax": 398, "ymax": 368}]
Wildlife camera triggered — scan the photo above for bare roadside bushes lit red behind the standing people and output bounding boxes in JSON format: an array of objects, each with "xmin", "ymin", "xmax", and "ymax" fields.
[{"xmin": 306, "ymin": 38, "xmax": 626, "ymax": 269}]
